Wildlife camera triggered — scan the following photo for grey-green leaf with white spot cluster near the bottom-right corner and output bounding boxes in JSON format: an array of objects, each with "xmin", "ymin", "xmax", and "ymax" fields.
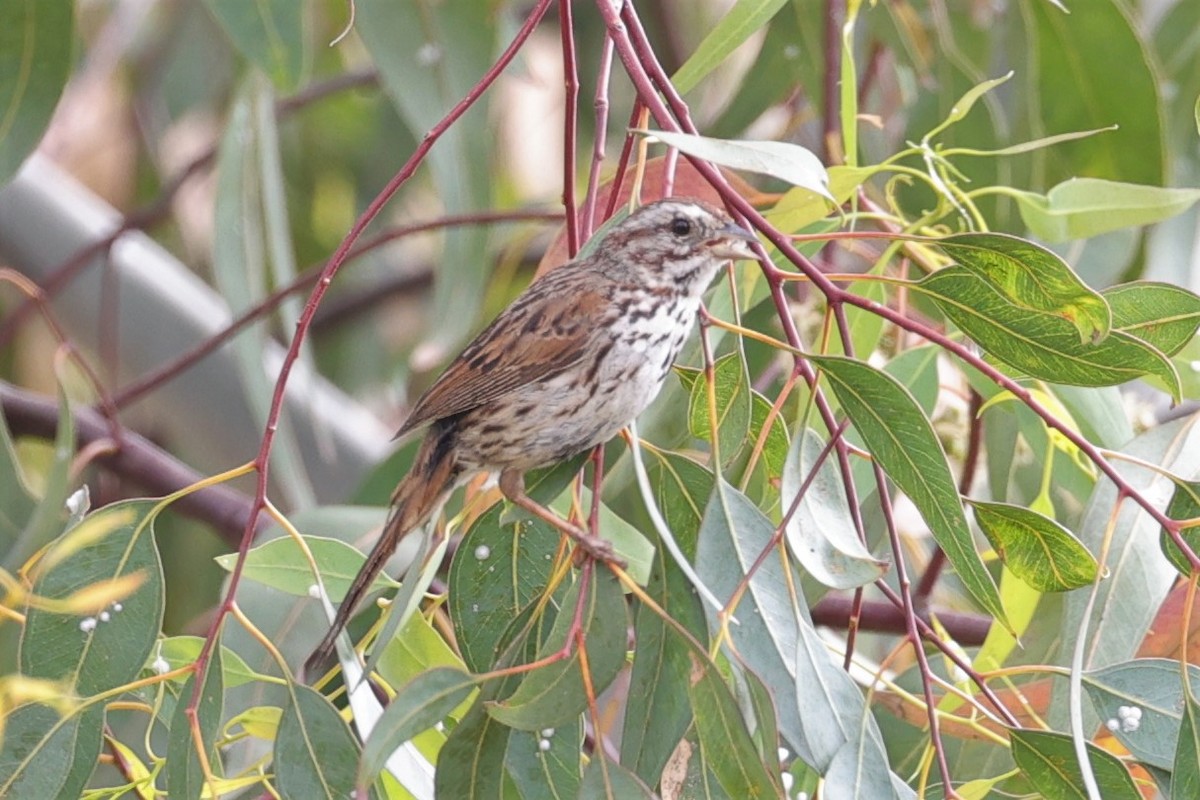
[{"xmin": 1082, "ymin": 658, "xmax": 1200, "ymax": 769}]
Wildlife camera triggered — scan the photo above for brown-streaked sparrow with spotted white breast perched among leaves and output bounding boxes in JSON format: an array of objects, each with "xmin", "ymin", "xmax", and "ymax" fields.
[{"xmin": 310, "ymin": 199, "xmax": 755, "ymax": 663}]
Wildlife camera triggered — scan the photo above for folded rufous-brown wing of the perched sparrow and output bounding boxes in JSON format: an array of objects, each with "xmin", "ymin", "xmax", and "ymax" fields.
[{"xmin": 396, "ymin": 277, "xmax": 611, "ymax": 437}]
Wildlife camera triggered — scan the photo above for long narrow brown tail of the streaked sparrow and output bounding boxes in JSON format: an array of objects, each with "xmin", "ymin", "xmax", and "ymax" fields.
[{"xmin": 307, "ymin": 423, "xmax": 461, "ymax": 672}]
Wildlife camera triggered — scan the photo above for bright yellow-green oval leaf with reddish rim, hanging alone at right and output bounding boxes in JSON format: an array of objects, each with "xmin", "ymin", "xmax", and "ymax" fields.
[{"xmin": 971, "ymin": 500, "xmax": 1099, "ymax": 591}]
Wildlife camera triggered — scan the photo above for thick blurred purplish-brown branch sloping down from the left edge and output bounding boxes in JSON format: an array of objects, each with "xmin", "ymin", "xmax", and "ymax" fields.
[{"xmin": 0, "ymin": 381, "xmax": 269, "ymax": 546}]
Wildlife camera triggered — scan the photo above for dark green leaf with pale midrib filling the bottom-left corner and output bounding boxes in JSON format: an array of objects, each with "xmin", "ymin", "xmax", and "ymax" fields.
[{"xmin": 0, "ymin": 703, "xmax": 104, "ymax": 798}]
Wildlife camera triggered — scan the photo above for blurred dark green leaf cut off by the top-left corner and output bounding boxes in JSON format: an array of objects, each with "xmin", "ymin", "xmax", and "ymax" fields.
[{"xmin": 0, "ymin": 0, "xmax": 74, "ymax": 186}]
